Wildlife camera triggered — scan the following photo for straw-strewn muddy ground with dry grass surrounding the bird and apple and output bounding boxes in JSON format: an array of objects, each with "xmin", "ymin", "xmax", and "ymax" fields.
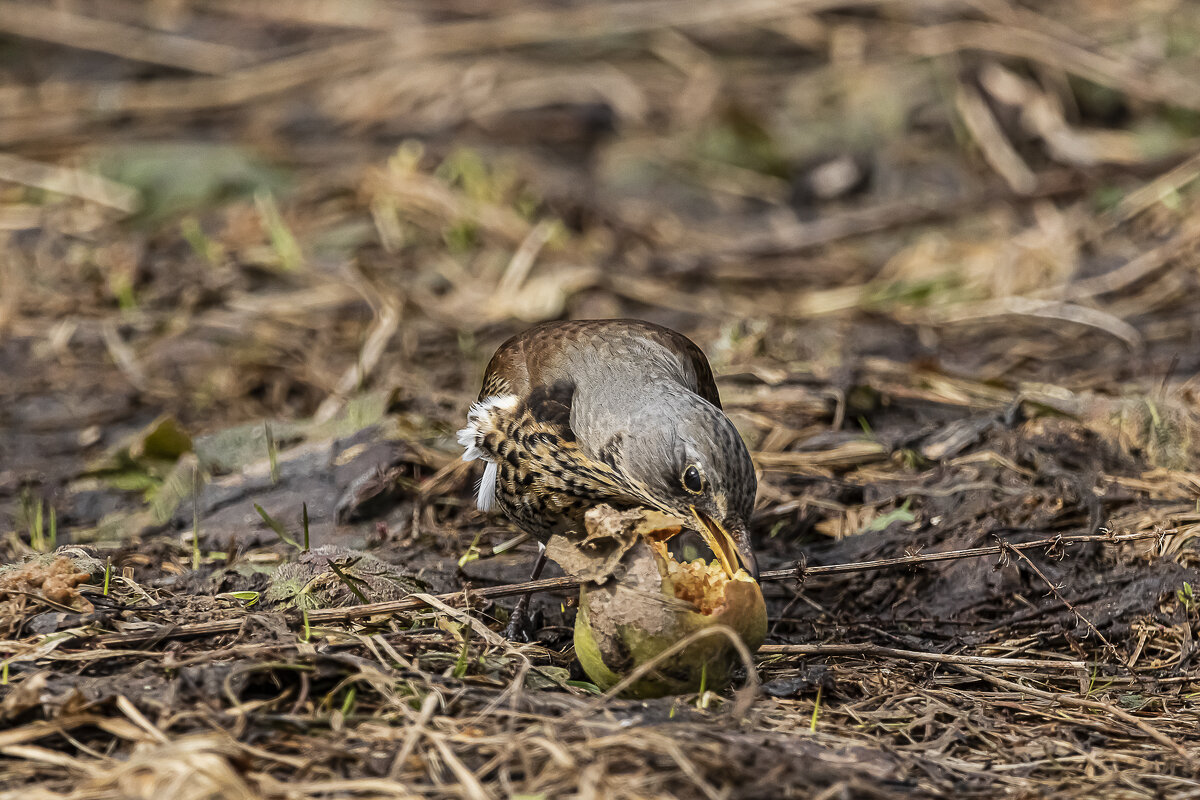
[{"xmin": 0, "ymin": 0, "xmax": 1200, "ymax": 800}]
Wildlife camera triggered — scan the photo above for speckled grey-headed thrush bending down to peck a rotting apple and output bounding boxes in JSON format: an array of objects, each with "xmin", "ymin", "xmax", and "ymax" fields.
[{"xmin": 457, "ymin": 319, "xmax": 758, "ymax": 636}]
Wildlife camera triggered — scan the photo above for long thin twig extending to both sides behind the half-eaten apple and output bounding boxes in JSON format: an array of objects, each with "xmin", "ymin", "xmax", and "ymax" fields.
[{"xmin": 87, "ymin": 531, "xmax": 1172, "ymax": 646}]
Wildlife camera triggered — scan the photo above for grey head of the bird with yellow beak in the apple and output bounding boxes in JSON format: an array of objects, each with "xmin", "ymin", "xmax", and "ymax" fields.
[{"xmin": 620, "ymin": 392, "xmax": 758, "ymax": 579}]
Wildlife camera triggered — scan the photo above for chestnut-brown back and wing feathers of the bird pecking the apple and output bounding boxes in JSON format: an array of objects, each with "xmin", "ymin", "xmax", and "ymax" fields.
[{"xmin": 479, "ymin": 319, "xmax": 721, "ymax": 408}]
